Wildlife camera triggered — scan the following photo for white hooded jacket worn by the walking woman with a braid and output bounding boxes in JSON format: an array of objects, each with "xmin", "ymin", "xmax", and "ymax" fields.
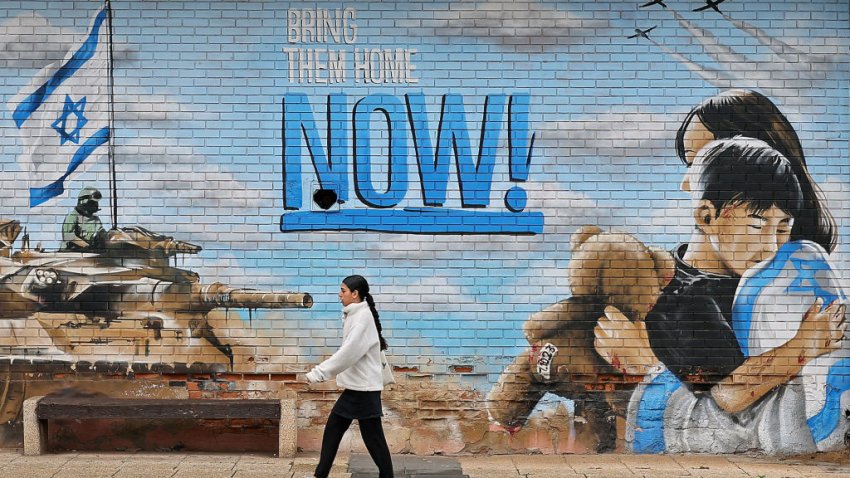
[{"xmin": 307, "ymin": 301, "xmax": 384, "ymax": 392}]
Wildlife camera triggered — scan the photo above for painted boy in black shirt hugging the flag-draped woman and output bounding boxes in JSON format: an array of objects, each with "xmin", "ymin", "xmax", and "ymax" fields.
[{"xmin": 595, "ymin": 137, "xmax": 845, "ymax": 453}]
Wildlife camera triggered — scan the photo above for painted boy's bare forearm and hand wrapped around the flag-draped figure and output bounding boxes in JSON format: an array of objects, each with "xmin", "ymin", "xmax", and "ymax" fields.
[{"xmin": 711, "ymin": 299, "xmax": 846, "ymax": 413}]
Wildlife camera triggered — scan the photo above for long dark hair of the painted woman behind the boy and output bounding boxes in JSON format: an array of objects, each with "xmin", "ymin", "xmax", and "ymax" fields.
[{"xmin": 676, "ymin": 89, "xmax": 838, "ymax": 252}]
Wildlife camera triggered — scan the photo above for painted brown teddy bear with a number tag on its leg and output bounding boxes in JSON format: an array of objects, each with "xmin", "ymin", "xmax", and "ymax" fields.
[{"xmin": 487, "ymin": 226, "xmax": 675, "ymax": 452}]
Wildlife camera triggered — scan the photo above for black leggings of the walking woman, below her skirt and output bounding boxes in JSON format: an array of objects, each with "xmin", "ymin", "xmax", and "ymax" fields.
[{"xmin": 315, "ymin": 412, "xmax": 393, "ymax": 478}]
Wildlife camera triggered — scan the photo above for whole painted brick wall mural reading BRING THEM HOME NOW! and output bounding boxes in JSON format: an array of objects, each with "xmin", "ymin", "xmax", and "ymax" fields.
[{"xmin": 0, "ymin": 0, "xmax": 850, "ymax": 454}]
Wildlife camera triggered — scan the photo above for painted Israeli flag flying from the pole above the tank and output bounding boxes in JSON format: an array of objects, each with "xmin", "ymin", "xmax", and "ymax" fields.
[{"xmin": 10, "ymin": 6, "xmax": 110, "ymax": 207}]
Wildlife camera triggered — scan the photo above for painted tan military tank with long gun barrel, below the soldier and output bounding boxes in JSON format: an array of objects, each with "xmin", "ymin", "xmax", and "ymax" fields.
[{"xmin": 0, "ymin": 220, "xmax": 313, "ymax": 367}]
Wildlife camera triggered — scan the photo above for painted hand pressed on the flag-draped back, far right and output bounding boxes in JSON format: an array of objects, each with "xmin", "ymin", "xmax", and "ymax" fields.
[{"xmin": 789, "ymin": 298, "xmax": 847, "ymax": 364}]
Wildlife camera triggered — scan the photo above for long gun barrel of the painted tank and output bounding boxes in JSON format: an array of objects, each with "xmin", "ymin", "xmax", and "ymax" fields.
[{"xmin": 196, "ymin": 282, "xmax": 313, "ymax": 309}]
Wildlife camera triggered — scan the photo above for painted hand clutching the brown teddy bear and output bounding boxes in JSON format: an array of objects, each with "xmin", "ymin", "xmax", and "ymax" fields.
[{"xmin": 593, "ymin": 305, "xmax": 660, "ymax": 375}]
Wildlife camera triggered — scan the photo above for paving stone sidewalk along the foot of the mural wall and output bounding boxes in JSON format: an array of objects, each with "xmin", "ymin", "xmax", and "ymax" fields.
[{"xmin": 0, "ymin": 450, "xmax": 850, "ymax": 478}]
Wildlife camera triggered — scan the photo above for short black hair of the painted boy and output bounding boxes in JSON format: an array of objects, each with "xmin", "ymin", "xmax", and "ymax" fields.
[{"xmin": 692, "ymin": 136, "xmax": 806, "ymax": 218}]
